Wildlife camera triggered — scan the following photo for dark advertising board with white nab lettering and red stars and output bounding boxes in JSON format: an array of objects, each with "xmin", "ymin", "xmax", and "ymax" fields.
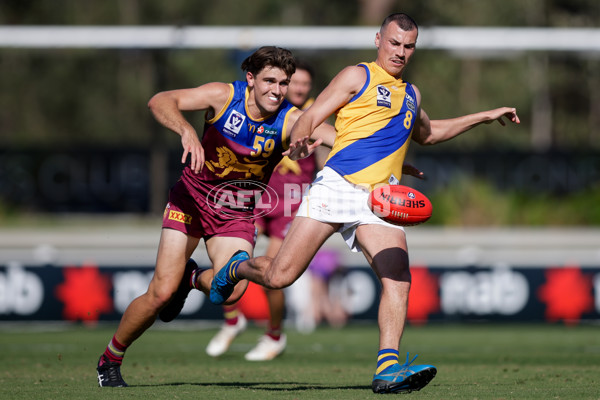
[{"xmin": 0, "ymin": 263, "xmax": 600, "ymax": 324}]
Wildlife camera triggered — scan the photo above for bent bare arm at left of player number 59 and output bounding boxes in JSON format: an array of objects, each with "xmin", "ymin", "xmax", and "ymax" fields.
[{"xmin": 148, "ymin": 83, "xmax": 230, "ymax": 173}]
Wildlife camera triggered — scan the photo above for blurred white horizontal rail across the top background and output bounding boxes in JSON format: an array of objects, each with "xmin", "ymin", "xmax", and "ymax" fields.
[{"xmin": 0, "ymin": 25, "xmax": 600, "ymax": 57}]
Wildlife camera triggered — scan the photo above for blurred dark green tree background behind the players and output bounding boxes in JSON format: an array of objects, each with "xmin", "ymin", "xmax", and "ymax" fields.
[{"xmin": 0, "ymin": 0, "xmax": 600, "ymax": 225}]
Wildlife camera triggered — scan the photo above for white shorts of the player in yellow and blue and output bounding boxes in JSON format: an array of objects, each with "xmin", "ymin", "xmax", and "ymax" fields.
[{"xmin": 296, "ymin": 167, "xmax": 404, "ymax": 252}]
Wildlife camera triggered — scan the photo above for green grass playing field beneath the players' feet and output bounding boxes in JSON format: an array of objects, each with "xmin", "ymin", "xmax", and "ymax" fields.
[{"xmin": 0, "ymin": 324, "xmax": 600, "ymax": 400}]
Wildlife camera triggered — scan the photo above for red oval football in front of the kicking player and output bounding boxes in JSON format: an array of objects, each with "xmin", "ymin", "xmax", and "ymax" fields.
[{"xmin": 369, "ymin": 185, "xmax": 433, "ymax": 226}]
